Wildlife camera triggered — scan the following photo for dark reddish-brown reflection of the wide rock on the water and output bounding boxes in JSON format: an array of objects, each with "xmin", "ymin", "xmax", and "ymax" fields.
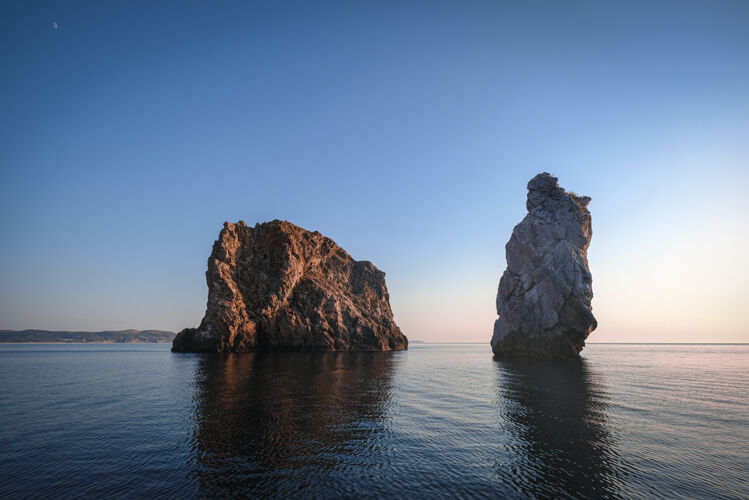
[{"xmin": 185, "ymin": 352, "xmax": 398, "ymax": 497}]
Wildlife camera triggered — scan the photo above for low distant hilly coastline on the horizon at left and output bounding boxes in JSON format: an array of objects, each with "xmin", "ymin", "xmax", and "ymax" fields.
[{"xmin": 0, "ymin": 330, "xmax": 175, "ymax": 344}]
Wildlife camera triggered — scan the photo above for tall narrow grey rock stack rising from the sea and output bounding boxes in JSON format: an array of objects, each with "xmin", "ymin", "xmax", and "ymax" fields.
[{"xmin": 491, "ymin": 173, "xmax": 597, "ymax": 358}]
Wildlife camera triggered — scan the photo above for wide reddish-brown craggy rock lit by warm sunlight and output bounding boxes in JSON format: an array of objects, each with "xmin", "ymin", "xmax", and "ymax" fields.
[{"xmin": 172, "ymin": 220, "xmax": 408, "ymax": 352}]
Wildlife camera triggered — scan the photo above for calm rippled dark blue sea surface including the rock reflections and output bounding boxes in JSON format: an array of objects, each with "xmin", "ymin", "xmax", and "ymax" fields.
[{"xmin": 0, "ymin": 344, "xmax": 749, "ymax": 498}]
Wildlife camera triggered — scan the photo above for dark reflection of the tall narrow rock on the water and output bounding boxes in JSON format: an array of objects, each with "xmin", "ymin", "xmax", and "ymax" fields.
[{"xmin": 495, "ymin": 358, "xmax": 628, "ymax": 498}]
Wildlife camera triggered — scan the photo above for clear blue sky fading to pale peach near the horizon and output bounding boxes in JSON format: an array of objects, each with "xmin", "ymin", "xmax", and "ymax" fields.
[{"xmin": 0, "ymin": 0, "xmax": 749, "ymax": 342}]
